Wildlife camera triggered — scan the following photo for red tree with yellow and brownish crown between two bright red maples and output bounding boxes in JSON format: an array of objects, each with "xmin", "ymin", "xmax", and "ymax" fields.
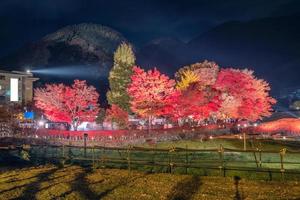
[{"xmin": 171, "ymin": 60, "xmax": 220, "ymax": 121}]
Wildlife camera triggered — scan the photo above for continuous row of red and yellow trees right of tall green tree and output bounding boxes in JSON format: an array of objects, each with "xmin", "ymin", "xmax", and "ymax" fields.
[{"xmin": 127, "ymin": 61, "xmax": 276, "ymax": 121}]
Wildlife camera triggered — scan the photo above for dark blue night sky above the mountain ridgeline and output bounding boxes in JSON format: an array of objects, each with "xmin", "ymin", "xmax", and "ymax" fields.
[{"xmin": 0, "ymin": 0, "xmax": 293, "ymax": 56}]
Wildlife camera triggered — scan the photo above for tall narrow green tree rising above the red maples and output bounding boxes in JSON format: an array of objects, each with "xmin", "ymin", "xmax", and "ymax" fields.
[{"xmin": 106, "ymin": 43, "xmax": 135, "ymax": 112}]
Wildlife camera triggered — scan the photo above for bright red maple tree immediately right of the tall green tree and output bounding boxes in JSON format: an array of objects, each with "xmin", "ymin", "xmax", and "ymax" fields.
[{"xmin": 127, "ymin": 67, "xmax": 175, "ymax": 124}]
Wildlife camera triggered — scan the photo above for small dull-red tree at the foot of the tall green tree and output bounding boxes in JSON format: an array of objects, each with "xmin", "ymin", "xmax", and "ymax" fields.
[{"xmin": 105, "ymin": 104, "xmax": 129, "ymax": 128}]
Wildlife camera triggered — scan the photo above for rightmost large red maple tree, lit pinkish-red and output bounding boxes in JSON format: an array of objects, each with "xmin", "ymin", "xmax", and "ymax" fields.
[{"xmin": 214, "ymin": 69, "xmax": 276, "ymax": 121}]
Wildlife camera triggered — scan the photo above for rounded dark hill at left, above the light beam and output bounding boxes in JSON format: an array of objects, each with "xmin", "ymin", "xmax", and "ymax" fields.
[{"xmin": 0, "ymin": 23, "xmax": 127, "ymax": 69}]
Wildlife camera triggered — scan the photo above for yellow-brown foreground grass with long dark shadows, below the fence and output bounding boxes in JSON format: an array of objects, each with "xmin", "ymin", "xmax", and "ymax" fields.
[{"xmin": 0, "ymin": 165, "xmax": 300, "ymax": 200}]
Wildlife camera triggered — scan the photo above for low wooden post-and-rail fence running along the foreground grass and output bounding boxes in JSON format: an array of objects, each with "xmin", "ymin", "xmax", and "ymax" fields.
[{"xmin": 7, "ymin": 145, "xmax": 300, "ymax": 180}]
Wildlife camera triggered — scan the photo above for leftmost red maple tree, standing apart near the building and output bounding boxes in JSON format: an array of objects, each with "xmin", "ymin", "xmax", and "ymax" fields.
[{"xmin": 34, "ymin": 80, "xmax": 99, "ymax": 130}]
